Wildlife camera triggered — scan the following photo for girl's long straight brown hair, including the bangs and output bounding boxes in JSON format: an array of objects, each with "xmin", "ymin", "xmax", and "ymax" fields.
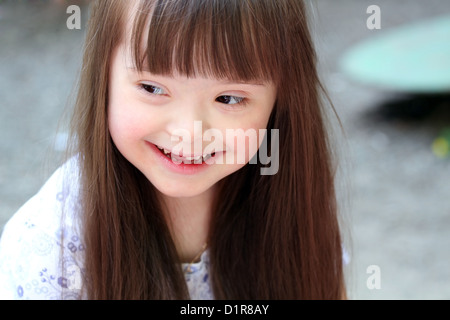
[{"xmin": 72, "ymin": 0, "xmax": 345, "ymax": 299}]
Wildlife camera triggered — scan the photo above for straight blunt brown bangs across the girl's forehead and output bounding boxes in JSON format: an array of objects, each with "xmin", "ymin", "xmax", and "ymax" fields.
[{"xmin": 131, "ymin": 0, "xmax": 285, "ymax": 83}]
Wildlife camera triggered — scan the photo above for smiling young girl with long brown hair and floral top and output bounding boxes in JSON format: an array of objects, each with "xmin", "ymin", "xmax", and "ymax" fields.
[{"xmin": 0, "ymin": 0, "xmax": 345, "ymax": 299}]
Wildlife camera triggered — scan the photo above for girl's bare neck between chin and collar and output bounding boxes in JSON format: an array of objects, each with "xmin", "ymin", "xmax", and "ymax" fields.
[{"xmin": 161, "ymin": 188, "xmax": 215, "ymax": 262}]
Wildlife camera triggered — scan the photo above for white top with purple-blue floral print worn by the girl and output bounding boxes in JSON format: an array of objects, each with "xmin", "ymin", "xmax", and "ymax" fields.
[{"xmin": 0, "ymin": 159, "xmax": 213, "ymax": 300}]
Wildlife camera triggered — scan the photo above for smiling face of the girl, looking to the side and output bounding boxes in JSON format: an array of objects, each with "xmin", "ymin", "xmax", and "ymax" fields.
[{"xmin": 108, "ymin": 44, "xmax": 276, "ymax": 197}]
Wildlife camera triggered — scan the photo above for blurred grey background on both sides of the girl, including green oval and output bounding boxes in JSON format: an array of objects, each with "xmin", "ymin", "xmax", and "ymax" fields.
[{"xmin": 0, "ymin": 0, "xmax": 450, "ymax": 299}]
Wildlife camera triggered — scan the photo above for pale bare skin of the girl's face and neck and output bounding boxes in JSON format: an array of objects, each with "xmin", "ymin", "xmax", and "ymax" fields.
[{"xmin": 108, "ymin": 24, "xmax": 276, "ymax": 262}]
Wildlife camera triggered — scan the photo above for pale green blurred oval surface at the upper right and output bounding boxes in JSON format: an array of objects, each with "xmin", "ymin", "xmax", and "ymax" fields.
[{"xmin": 340, "ymin": 15, "xmax": 450, "ymax": 93}]
